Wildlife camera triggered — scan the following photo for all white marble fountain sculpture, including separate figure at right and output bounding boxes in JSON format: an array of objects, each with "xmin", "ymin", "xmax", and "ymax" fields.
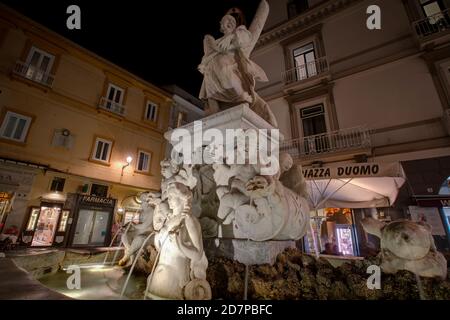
[{"xmin": 119, "ymin": 0, "xmax": 445, "ymax": 299}]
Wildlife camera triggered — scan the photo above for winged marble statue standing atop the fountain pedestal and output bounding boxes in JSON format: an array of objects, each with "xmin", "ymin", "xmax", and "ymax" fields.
[{"xmin": 198, "ymin": 0, "xmax": 278, "ymax": 127}]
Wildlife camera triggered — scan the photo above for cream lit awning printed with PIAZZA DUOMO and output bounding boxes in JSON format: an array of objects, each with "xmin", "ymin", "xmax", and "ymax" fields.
[{"xmin": 303, "ymin": 163, "xmax": 405, "ymax": 210}]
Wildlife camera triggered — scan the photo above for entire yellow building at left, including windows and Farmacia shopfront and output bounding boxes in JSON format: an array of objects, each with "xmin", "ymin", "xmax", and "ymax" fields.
[{"xmin": 0, "ymin": 6, "xmax": 173, "ymax": 246}]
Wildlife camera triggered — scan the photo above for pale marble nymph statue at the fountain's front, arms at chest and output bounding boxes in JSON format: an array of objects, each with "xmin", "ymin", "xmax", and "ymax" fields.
[{"xmin": 147, "ymin": 182, "xmax": 211, "ymax": 300}]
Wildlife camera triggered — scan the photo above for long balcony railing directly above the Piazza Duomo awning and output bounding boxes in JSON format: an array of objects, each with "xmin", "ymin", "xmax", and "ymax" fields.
[{"xmin": 280, "ymin": 126, "xmax": 371, "ymax": 158}]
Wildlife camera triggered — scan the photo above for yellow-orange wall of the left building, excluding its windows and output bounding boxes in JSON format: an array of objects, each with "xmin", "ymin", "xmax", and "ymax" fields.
[{"xmin": 0, "ymin": 10, "xmax": 173, "ymax": 234}]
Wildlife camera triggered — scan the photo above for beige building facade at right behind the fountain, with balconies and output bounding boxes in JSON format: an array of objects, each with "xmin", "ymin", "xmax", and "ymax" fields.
[{"xmin": 252, "ymin": 0, "xmax": 450, "ymax": 255}]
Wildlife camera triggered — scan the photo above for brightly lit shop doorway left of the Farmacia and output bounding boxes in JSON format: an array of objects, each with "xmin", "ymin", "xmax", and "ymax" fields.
[{"xmin": 31, "ymin": 205, "xmax": 61, "ymax": 247}]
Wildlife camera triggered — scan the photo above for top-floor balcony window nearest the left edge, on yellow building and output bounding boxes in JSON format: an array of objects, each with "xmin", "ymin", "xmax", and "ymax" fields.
[{"xmin": 24, "ymin": 47, "xmax": 55, "ymax": 82}]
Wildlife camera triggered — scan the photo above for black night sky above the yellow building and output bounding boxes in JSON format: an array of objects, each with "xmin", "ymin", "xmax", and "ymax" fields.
[{"xmin": 0, "ymin": 0, "xmax": 259, "ymax": 96}]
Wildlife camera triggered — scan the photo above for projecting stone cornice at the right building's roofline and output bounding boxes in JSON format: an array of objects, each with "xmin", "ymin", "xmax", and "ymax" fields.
[{"xmin": 255, "ymin": 0, "xmax": 363, "ymax": 49}]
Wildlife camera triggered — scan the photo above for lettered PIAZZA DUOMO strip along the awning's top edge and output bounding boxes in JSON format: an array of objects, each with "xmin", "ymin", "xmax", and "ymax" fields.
[{"xmin": 303, "ymin": 163, "xmax": 399, "ymax": 180}]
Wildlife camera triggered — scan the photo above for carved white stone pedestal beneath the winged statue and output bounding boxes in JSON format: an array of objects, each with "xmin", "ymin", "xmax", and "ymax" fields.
[{"xmin": 164, "ymin": 104, "xmax": 309, "ymax": 265}]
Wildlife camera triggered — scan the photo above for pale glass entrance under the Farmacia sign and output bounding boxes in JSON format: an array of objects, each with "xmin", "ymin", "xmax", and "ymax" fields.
[{"xmin": 72, "ymin": 209, "xmax": 110, "ymax": 246}]
